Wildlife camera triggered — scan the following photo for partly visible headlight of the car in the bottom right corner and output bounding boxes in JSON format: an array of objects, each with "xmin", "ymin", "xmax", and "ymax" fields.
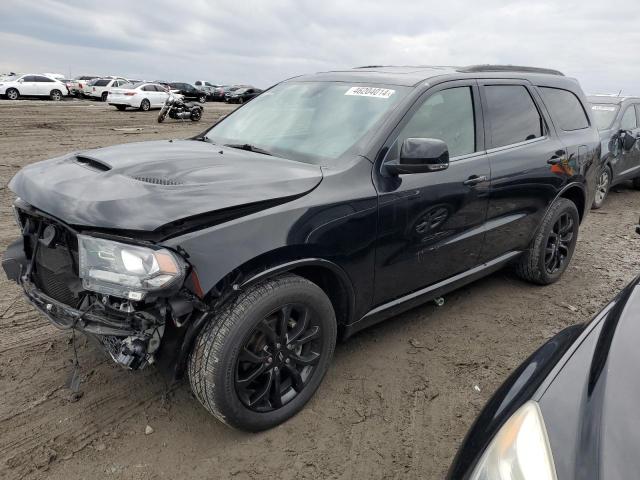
[{"xmin": 470, "ymin": 401, "xmax": 557, "ymax": 480}]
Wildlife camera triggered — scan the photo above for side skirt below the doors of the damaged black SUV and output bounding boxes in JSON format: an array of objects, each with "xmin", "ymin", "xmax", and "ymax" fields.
[{"xmin": 343, "ymin": 251, "xmax": 522, "ymax": 338}]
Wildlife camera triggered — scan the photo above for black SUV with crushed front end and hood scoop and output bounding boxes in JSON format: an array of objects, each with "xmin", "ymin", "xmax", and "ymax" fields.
[{"xmin": 3, "ymin": 66, "xmax": 600, "ymax": 430}]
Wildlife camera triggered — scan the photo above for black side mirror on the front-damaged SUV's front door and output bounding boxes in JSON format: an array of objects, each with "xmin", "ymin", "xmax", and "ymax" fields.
[{"xmin": 384, "ymin": 138, "xmax": 449, "ymax": 175}]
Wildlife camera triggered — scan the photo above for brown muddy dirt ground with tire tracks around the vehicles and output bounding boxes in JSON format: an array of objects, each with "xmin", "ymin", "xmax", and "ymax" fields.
[{"xmin": 0, "ymin": 100, "xmax": 640, "ymax": 480}]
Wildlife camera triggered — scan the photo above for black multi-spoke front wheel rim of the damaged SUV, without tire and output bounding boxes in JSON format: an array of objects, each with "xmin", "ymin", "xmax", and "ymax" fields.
[{"xmin": 235, "ymin": 304, "xmax": 324, "ymax": 412}]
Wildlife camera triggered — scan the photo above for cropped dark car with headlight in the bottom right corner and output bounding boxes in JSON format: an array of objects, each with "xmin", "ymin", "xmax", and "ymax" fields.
[{"xmin": 448, "ymin": 220, "xmax": 640, "ymax": 480}]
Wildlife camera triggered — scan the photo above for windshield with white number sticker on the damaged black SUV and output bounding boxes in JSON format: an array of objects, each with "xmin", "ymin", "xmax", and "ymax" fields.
[{"xmin": 205, "ymin": 82, "xmax": 409, "ymax": 164}]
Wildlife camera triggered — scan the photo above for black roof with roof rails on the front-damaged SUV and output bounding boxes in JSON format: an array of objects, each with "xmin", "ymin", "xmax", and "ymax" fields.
[{"xmin": 295, "ymin": 65, "xmax": 575, "ymax": 87}]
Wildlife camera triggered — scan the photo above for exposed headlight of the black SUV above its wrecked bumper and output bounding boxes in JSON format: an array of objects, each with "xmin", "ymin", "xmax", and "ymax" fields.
[{"xmin": 78, "ymin": 235, "xmax": 185, "ymax": 300}]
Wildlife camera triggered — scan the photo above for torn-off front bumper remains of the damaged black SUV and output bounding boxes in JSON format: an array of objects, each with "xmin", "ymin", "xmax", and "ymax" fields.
[{"xmin": 2, "ymin": 206, "xmax": 198, "ymax": 370}]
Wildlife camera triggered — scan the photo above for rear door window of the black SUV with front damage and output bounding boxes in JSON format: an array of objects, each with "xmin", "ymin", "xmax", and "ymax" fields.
[{"xmin": 484, "ymin": 85, "xmax": 544, "ymax": 148}]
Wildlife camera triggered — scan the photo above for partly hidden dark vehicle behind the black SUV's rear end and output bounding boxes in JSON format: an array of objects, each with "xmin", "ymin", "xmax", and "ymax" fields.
[{"xmin": 588, "ymin": 95, "xmax": 640, "ymax": 208}]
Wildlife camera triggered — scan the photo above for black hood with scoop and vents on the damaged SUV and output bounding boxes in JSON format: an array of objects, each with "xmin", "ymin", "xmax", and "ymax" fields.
[{"xmin": 9, "ymin": 140, "xmax": 322, "ymax": 232}]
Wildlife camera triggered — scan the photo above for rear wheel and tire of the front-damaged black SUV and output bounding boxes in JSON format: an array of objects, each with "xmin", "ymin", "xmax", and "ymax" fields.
[{"xmin": 516, "ymin": 198, "xmax": 580, "ymax": 285}]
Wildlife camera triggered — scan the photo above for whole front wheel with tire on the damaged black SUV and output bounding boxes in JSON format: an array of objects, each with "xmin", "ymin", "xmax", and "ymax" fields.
[{"xmin": 189, "ymin": 275, "xmax": 337, "ymax": 431}]
